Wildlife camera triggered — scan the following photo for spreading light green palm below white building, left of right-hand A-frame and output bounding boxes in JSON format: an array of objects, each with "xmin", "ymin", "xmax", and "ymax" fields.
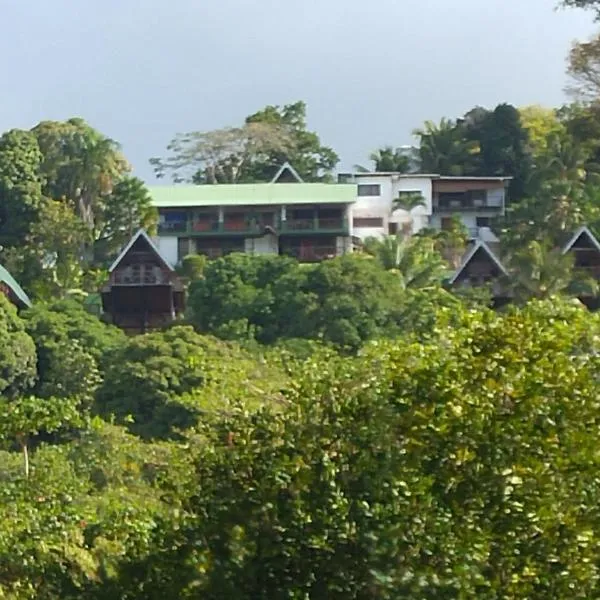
[{"xmin": 364, "ymin": 235, "xmax": 447, "ymax": 289}]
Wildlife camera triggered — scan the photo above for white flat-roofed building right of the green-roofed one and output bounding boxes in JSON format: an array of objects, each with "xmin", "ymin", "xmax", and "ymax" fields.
[{"xmin": 339, "ymin": 173, "xmax": 510, "ymax": 240}]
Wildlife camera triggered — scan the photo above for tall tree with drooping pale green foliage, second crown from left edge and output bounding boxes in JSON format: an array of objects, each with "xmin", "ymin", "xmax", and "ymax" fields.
[{"xmin": 32, "ymin": 118, "xmax": 130, "ymax": 232}]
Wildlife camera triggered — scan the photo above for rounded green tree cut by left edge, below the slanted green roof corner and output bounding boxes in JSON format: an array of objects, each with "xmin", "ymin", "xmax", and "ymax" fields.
[{"xmin": 0, "ymin": 294, "xmax": 37, "ymax": 400}]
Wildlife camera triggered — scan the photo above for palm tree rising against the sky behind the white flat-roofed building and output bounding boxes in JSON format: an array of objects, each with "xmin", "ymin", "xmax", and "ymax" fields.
[{"xmin": 413, "ymin": 118, "xmax": 480, "ymax": 175}]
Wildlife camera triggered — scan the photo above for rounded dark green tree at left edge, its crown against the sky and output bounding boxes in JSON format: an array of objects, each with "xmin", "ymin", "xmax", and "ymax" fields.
[{"xmin": 0, "ymin": 129, "xmax": 43, "ymax": 248}]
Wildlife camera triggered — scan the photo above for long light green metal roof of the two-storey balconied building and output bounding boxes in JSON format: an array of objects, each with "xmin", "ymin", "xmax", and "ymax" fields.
[{"xmin": 148, "ymin": 183, "xmax": 356, "ymax": 208}]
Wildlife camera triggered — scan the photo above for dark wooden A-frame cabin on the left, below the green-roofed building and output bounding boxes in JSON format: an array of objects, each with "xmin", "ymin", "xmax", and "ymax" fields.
[{"xmin": 102, "ymin": 230, "xmax": 185, "ymax": 334}]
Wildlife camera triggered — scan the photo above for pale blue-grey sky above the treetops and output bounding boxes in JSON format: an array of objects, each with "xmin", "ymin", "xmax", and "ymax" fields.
[{"xmin": 0, "ymin": 0, "xmax": 594, "ymax": 183}]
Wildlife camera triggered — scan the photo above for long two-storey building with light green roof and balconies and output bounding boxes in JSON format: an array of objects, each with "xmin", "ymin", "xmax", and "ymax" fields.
[{"xmin": 150, "ymin": 181, "xmax": 356, "ymax": 264}]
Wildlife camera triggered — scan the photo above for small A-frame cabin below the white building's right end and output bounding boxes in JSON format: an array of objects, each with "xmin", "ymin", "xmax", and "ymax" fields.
[{"xmin": 449, "ymin": 240, "xmax": 508, "ymax": 305}]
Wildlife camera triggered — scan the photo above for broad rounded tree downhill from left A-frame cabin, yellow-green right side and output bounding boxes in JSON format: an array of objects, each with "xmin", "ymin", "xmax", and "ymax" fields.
[{"xmin": 95, "ymin": 326, "xmax": 281, "ymax": 439}]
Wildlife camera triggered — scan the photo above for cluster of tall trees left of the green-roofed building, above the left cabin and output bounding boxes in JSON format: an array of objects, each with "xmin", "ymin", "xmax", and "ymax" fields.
[{"xmin": 0, "ymin": 119, "xmax": 157, "ymax": 300}]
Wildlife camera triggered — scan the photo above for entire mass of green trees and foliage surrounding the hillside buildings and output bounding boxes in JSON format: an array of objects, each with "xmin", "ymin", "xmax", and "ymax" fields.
[{"xmin": 0, "ymin": 0, "xmax": 600, "ymax": 600}]
